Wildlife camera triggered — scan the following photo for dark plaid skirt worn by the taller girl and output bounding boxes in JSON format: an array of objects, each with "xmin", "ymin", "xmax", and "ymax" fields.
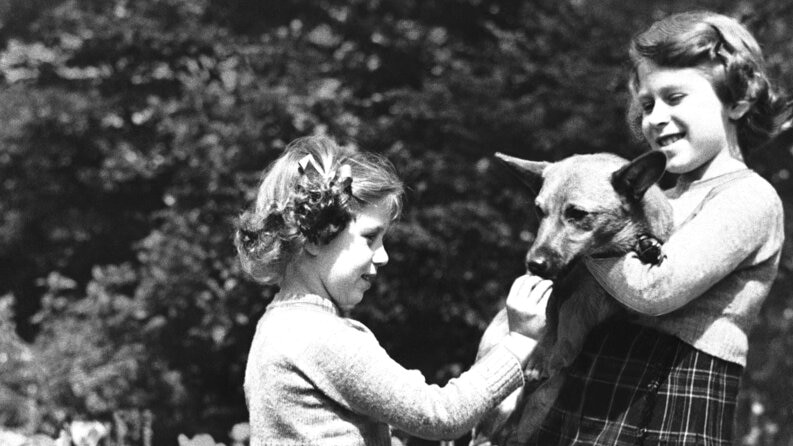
[{"xmin": 529, "ymin": 322, "xmax": 743, "ymax": 446}]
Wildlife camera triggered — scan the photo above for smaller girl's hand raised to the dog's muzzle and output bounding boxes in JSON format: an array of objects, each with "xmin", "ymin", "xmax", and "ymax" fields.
[{"xmin": 507, "ymin": 274, "xmax": 553, "ymax": 340}]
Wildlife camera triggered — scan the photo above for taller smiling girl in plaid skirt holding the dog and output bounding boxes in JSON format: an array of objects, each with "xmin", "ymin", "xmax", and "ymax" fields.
[{"xmin": 532, "ymin": 12, "xmax": 788, "ymax": 446}]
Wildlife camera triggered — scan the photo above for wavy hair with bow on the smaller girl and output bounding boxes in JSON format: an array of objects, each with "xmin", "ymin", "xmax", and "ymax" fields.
[{"xmin": 234, "ymin": 136, "xmax": 403, "ymax": 284}]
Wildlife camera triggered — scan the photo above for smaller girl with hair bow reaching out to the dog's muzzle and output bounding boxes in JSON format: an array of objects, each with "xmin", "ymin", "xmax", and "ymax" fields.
[{"xmin": 236, "ymin": 137, "xmax": 538, "ymax": 446}]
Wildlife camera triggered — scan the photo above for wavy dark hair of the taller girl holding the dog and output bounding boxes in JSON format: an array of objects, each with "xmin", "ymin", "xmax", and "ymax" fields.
[{"xmin": 628, "ymin": 11, "xmax": 789, "ymax": 158}]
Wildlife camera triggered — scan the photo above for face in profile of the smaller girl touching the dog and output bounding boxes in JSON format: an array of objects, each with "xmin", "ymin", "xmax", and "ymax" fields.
[{"xmin": 315, "ymin": 199, "xmax": 391, "ymax": 310}]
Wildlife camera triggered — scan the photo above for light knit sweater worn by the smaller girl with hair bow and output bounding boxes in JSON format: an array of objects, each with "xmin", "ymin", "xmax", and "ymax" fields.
[{"xmin": 245, "ymin": 294, "xmax": 523, "ymax": 446}]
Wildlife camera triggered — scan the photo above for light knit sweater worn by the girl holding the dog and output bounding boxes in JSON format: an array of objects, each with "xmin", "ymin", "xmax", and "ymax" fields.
[{"xmin": 587, "ymin": 169, "xmax": 784, "ymax": 366}]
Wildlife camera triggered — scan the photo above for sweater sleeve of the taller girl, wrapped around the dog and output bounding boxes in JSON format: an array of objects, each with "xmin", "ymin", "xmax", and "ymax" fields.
[{"xmin": 586, "ymin": 182, "xmax": 784, "ymax": 316}]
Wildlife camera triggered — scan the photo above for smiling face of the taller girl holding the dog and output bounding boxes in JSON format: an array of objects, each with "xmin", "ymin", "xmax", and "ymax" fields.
[{"xmin": 634, "ymin": 61, "xmax": 742, "ymax": 180}]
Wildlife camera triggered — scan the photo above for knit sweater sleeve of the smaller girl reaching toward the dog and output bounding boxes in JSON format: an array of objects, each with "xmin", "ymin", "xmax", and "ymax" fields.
[{"xmin": 304, "ymin": 321, "xmax": 523, "ymax": 440}]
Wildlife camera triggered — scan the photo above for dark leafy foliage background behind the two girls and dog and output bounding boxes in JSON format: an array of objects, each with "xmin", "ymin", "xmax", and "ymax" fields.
[{"xmin": 0, "ymin": 0, "xmax": 793, "ymax": 445}]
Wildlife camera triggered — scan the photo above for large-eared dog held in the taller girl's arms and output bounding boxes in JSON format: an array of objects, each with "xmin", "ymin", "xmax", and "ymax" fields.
[{"xmin": 476, "ymin": 152, "xmax": 672, "ymax": 444}]
